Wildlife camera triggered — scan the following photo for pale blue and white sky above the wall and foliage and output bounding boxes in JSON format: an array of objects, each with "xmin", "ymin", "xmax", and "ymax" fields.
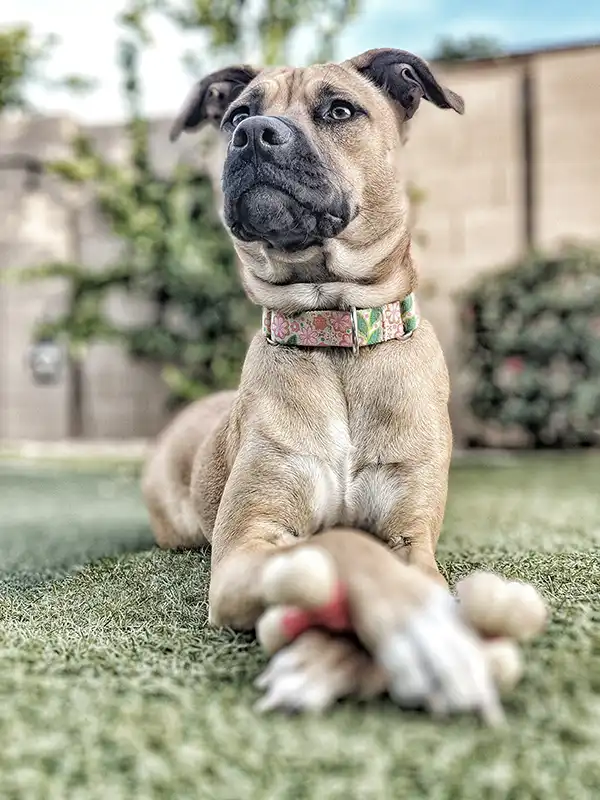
[{"xmin": 0, "ymin": 0, "xmax": 600, "ymax": 123}]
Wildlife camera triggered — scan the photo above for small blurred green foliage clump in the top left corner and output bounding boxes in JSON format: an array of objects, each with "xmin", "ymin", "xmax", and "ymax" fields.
[{"xmin": 0, "ymin": 25, "xmax": 94, "ymax": 114}]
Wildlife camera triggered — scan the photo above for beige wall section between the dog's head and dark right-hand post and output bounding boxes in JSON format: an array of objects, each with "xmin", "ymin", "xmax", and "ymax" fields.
[{"xmin": 406, "ymin": 62, "xmax": 523, "ymax": 439}]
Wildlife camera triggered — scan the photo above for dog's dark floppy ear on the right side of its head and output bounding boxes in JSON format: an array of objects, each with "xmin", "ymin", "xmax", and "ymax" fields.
[{"xmin": 348, "ymin": 48, "xmax": 465, "ymax": 119}]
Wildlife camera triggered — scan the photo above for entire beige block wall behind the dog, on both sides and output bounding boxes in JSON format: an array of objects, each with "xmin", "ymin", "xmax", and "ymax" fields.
[{"xmin": 0, "ymin": 43, "xmax": 600, "ymax": 442}]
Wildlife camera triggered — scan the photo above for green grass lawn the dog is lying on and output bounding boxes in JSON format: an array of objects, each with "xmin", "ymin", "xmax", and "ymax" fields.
[{"xmin": 0, "ymin": 456, "xmax": 600, "ymax": 800}]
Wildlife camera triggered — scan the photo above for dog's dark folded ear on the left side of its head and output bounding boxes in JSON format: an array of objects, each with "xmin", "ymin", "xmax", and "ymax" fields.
[{"xmin": 169, "ymin": 64, "xmax": 259, "ymax": 142}]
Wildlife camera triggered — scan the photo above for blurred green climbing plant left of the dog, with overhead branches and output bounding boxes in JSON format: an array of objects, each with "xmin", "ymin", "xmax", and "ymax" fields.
[{"xmin": 21, "ymin": 0, "xmax": 355, "ymax": 403}]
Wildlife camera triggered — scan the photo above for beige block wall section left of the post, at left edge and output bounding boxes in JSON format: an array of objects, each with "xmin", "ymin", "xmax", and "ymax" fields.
[{"xmin": 0, "ymin": 119, "xmax": 76, "ymax": 439}]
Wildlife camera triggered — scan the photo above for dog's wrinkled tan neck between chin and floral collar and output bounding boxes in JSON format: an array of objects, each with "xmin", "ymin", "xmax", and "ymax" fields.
[{"xmin": 237, "ymin": 226, "xmax": 417, "ymax": 314}]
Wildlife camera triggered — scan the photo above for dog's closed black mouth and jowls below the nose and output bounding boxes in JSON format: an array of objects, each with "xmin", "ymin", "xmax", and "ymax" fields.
[{"xmin": 223, "ymin": 161, "xmax": 352, "ymax": 252}]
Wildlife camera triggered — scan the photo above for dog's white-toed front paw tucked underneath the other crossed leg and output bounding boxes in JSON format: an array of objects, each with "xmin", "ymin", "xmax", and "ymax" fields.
[{"xmin": 256, "ymin": 630, "xmax": 386, "ymax": 713}]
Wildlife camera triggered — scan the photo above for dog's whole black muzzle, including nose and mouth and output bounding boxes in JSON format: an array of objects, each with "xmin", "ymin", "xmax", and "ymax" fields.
[{"xmin": 223, "ymin": 116, "xmax": 352, "ymax": 252}]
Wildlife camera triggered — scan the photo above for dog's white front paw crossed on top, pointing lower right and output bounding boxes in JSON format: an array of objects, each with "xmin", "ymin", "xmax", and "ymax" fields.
[{"xmin": 375, "ymin": 587, "xmax": 504, "ymax": 724}]
